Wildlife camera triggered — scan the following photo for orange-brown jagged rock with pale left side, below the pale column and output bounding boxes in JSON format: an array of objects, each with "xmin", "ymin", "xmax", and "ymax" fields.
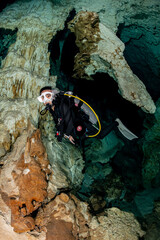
[{"xmin": 0, "ymin": 130, "xmax": 50, "ymax": 233}]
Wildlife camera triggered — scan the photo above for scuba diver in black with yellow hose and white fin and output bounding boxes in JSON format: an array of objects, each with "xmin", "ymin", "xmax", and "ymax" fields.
[{"xmin": 37, "ymin": 86, "xmax": 137, "ymax": 145}]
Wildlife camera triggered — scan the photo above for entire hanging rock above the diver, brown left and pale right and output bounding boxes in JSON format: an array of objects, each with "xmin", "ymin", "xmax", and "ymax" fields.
[{"xmin": 69, "ymin": 11, "xmax": 156, "ymax": 113}]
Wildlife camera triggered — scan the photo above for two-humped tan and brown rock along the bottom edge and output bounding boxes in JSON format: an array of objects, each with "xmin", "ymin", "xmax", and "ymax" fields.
[{"xmin": 36, "ymin": 194, "xmax": 144, "ymax": 240}]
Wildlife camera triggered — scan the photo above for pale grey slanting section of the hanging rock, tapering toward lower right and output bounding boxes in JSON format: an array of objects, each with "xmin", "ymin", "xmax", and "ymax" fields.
[{"xmin": 85, "ymin": 23, "xmax": 156, "ymax": 113}]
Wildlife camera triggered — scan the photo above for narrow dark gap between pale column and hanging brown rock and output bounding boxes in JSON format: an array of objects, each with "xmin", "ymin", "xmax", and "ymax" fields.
[{"xmin": 48, "ymin": 9, "xmax": 79, "ymax": 91}]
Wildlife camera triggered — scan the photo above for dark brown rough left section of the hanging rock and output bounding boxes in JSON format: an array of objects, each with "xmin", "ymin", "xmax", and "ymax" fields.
[{"xmin": 68, "ymin": 11, "xmax": 100, "ymax": 79}]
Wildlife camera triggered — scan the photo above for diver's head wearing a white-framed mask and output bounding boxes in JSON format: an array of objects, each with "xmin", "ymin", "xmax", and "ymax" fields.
[{"xmin": 37, "ymin": 86, "xmax": 55, "ymax": 105}]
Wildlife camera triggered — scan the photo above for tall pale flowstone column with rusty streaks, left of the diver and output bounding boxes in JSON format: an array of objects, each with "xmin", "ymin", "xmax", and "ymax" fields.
[{"xmin": 0, "ymin": 0, "xmax": 70, "ymax": 156}]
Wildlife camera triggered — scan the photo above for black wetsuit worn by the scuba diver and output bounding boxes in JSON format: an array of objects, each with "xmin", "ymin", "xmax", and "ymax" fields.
[{"xmin": 49, "ymin": 92, "xmax": 118, "ymax": 141}]
